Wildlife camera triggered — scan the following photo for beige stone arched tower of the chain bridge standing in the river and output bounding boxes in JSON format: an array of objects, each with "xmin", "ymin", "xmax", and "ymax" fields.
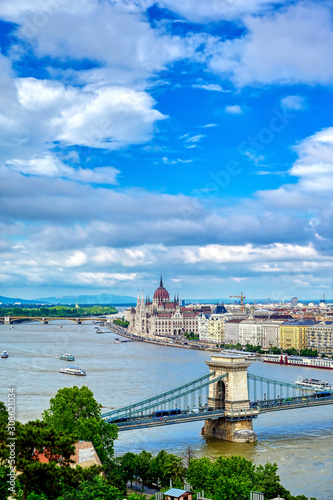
[{"xmin": 202, "ymin": 355, "xmax": 258, "ymax": 443}]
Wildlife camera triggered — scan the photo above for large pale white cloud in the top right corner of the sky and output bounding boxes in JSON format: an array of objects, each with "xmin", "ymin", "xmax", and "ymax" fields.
[{"xmin": 206, "ymin": 2, "xmax": 333, "ymax": 86}]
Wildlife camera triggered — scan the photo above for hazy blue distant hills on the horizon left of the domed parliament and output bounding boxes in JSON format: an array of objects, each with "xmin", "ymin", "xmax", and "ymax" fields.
[{"xmin": 0, "ymin": 293, "xmax": 136, "ymax": 305}]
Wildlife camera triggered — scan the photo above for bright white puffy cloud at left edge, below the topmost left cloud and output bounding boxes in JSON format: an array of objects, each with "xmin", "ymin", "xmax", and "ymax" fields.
[{"xmin": 0, "ymin": 74, "xmax": 166, "ymax": 155}]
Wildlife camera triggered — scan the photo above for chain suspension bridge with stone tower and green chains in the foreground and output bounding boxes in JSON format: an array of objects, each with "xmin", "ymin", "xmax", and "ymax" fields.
[{"xmin": 102, "ymin": 355, "xmax": 333, "ymax": 442}]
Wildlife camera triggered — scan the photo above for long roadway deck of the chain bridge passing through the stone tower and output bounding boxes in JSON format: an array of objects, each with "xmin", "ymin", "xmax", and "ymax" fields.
[{"xmin": 102, "ymin": 394, "xmax": 333, "ymax": 431}]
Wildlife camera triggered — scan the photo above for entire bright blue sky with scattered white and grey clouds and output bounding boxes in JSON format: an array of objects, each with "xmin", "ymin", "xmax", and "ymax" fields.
[{"xmin": 0, "ymin": 0, "xmax": 333, "ymax": 300}]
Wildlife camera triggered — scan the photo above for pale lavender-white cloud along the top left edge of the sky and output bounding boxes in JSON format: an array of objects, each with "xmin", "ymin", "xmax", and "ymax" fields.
[{"xmin": 0, "ymin": 0, "xmax": 201, "ymax": 84}]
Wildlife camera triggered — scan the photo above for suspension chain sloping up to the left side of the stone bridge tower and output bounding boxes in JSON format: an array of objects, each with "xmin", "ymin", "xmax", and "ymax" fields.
[{"xmin": 102, "ymin": 372, "xmax": 228, "ymax": 423}]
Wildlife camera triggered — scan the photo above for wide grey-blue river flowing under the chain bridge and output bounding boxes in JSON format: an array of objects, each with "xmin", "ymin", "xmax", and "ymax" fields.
[{"xmin": 0, "ymin": 321, "xmax": 333, "ymax": 500}]
